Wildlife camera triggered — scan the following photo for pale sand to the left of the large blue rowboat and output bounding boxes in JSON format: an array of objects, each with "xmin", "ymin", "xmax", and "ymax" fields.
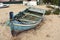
[{"xmin": 0, "ymin": 4, "xmax": 26, "ymax": 40}]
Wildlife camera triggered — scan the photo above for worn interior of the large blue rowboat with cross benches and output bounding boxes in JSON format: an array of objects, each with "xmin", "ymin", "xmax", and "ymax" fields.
[{"xmin": 14, "ymin": 9, "xmax": 43, "ymax": 24}]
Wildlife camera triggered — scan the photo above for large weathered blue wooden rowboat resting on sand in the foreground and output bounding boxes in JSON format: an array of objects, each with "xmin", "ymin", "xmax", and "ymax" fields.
[{"xmin": 9, "ymin": 7, "xmax": 46, "ymax": 31}]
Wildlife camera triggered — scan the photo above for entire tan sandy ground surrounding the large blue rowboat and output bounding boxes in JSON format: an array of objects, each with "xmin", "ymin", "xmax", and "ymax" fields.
[{"xmin": 0, "ymin": 4, "xmax": 60, "ymax": 40}]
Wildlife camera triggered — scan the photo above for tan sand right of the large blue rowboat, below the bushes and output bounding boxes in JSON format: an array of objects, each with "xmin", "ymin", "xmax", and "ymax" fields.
[{"xmin": 14, "ymin": 15, "xmax": 60, "ymax": 40}]
